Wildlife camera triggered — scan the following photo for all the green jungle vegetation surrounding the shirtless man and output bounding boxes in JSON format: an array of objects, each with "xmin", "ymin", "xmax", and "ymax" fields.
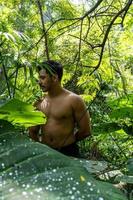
[{"xmin": 0, "ymin": 0, "xmax": 133, "ymax": 200}]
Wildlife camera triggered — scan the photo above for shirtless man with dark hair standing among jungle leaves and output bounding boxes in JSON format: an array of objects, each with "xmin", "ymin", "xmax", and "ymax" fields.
[{"xmin": 29, "ymin": 60, "xmax": 91, "ymax": 157}]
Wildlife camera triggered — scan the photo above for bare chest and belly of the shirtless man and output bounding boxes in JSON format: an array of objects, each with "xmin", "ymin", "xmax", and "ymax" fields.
[{"xmin": 37, "ymin": 91, "xmax": 75, "ymax": 148}]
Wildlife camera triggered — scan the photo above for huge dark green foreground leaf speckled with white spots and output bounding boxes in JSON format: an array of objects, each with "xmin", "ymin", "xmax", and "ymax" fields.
[{"xmin": 0, "ymin": 127, "xmax": 126, "ymax": 200}]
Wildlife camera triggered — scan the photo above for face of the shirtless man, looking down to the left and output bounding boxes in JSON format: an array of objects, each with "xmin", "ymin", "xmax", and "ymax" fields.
[{"xmin": 39, "ymin": 69, "xmax": 52, "ymax": 92}]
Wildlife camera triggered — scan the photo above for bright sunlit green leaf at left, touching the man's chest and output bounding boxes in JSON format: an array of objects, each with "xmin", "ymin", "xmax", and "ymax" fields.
[{"xmin": 0, "ymin": 99, "xmax": 46, "ymax": 127}]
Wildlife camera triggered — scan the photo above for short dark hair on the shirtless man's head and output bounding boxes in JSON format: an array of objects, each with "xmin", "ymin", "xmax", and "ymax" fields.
[{"xmin": 37, "ymin": 60, "xmax": 63, "ymax": 81}]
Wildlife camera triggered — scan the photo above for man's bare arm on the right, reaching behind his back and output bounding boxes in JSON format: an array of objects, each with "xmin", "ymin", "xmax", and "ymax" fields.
[{"xmin": 73, "ymin": 95, "xmax": 91, "ymax": 141}]
